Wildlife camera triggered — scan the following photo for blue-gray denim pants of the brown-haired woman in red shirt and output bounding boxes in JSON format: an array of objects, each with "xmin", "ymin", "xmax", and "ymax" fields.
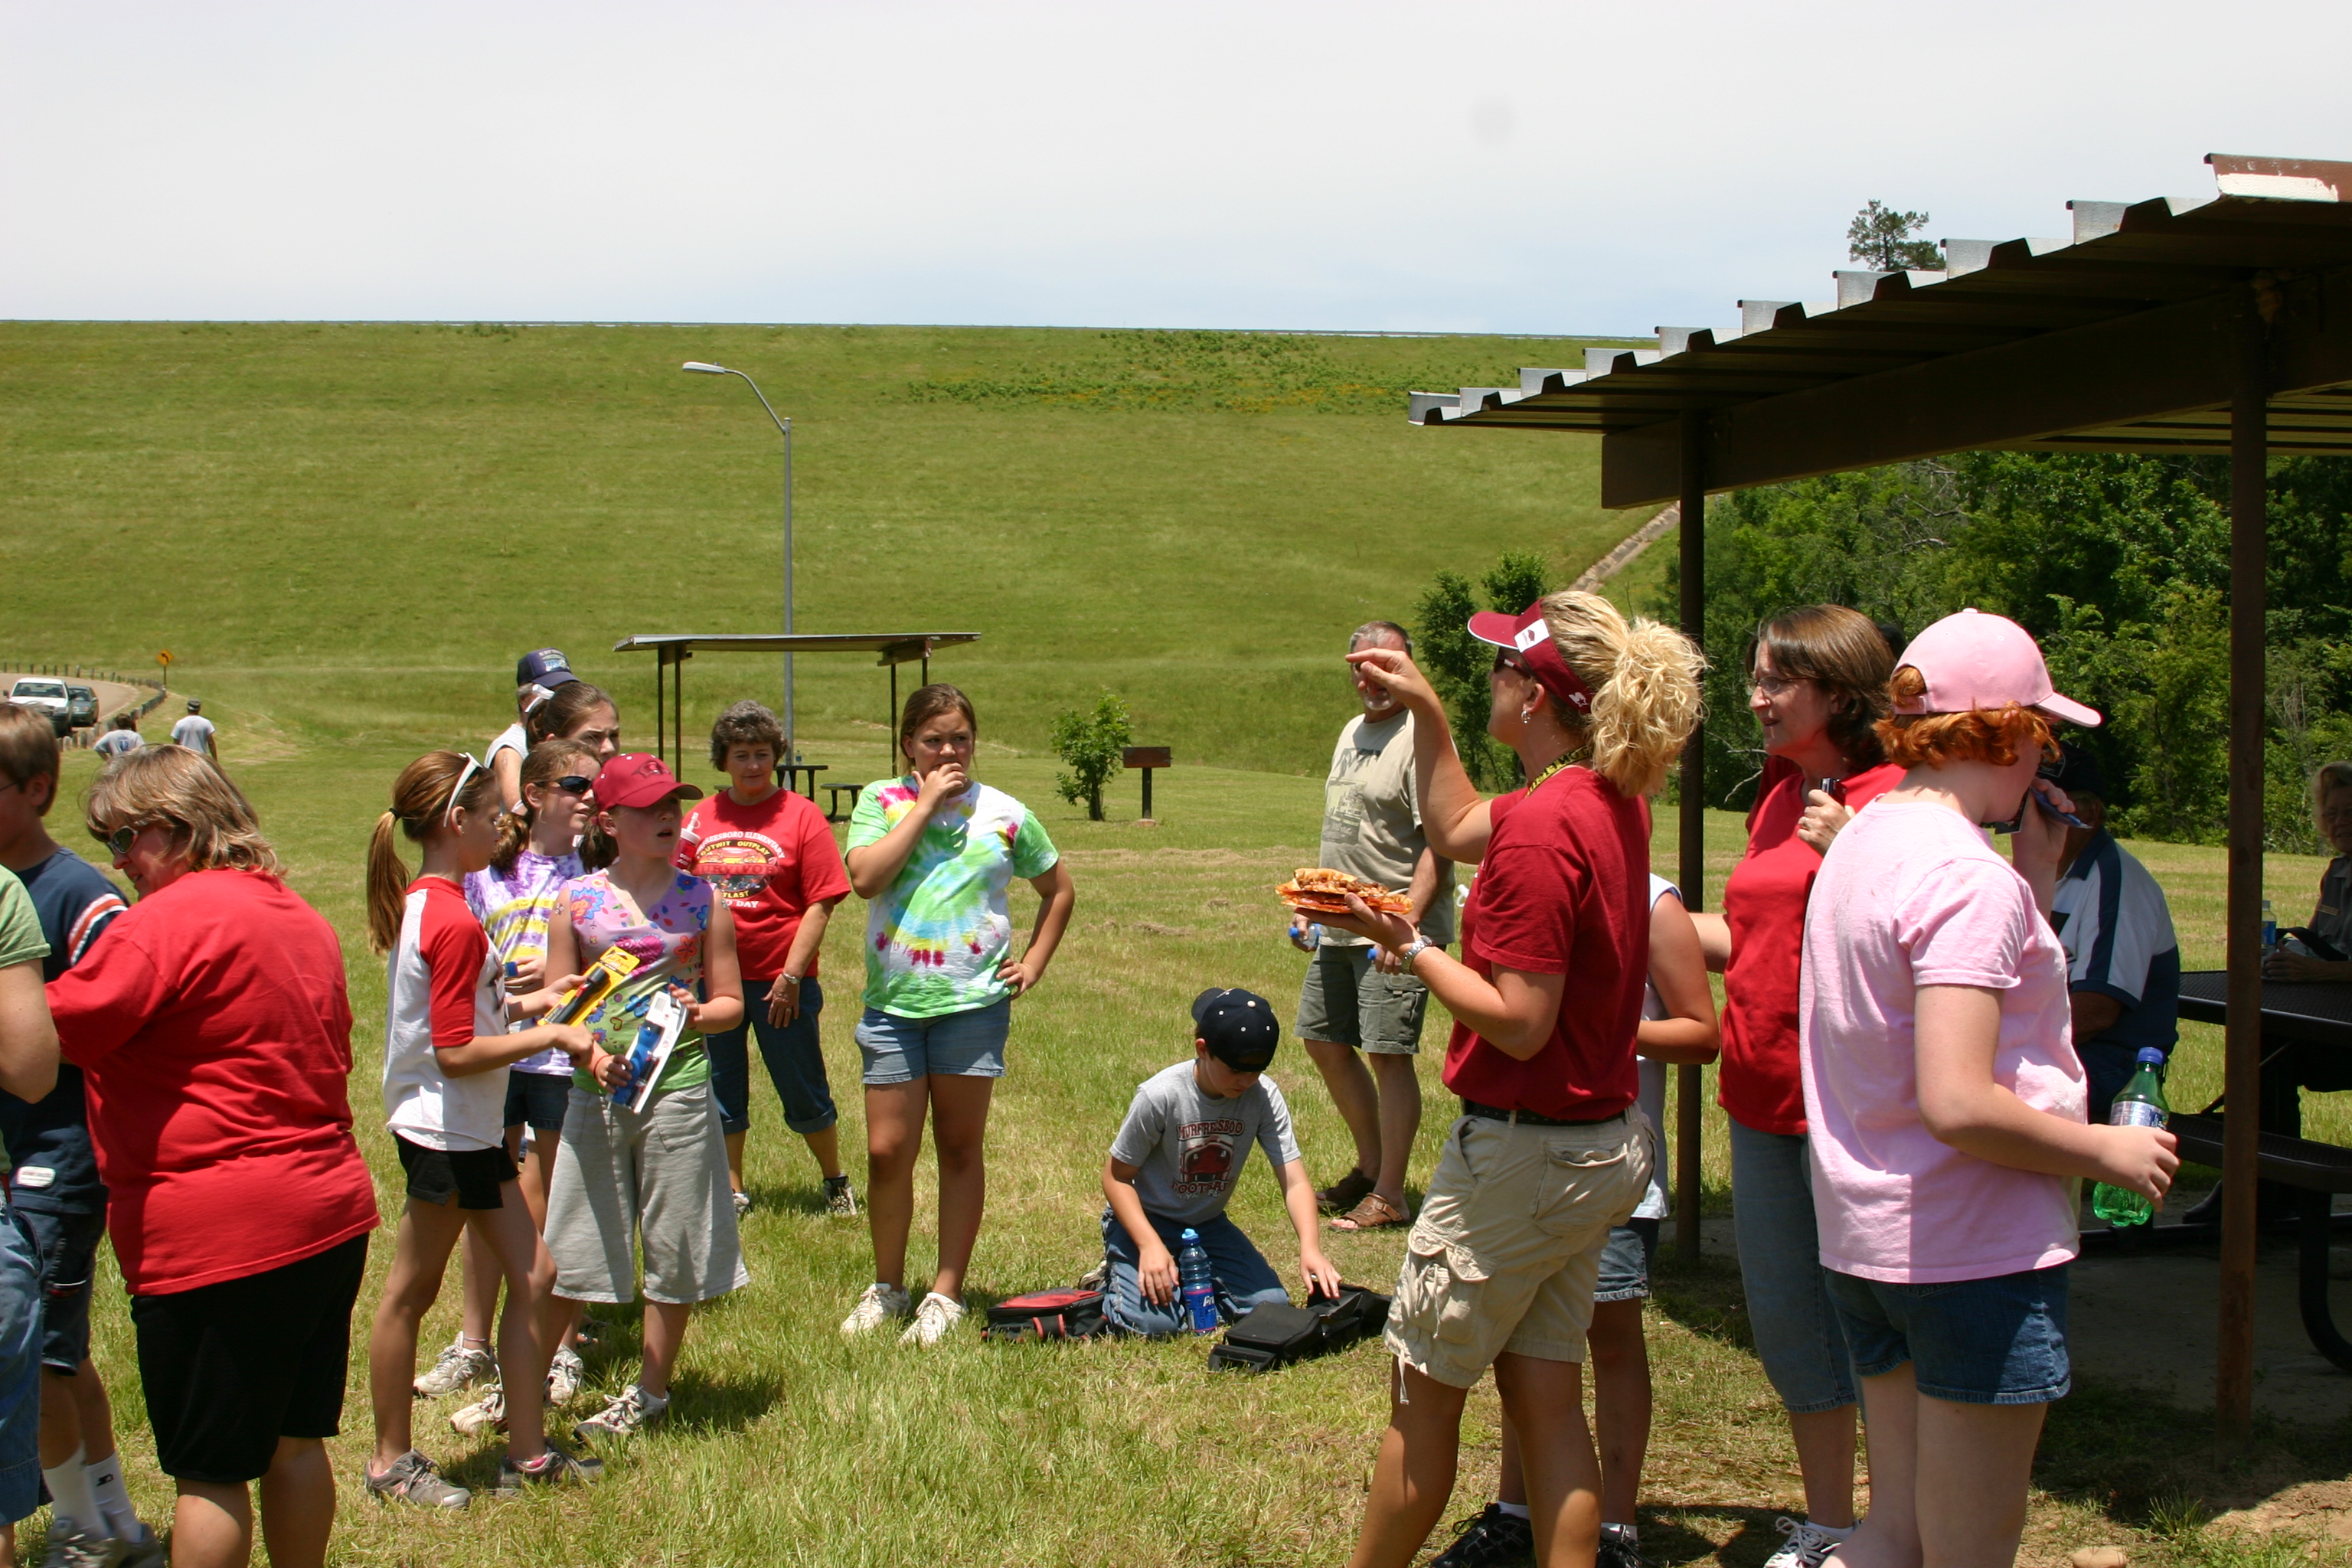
[{"xmin": 1731, "ymin": 1122, "xmax": 1854, "ymax": 1415}]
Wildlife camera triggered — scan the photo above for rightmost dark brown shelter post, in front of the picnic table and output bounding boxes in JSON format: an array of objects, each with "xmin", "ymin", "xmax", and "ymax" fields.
[{"xmin": 2213, "ymin": 289, "xmax": 2269, "ymax": 1441}]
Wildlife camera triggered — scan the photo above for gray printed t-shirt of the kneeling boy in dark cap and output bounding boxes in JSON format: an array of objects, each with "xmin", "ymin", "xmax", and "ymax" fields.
[{"xmin": 1110, "ymin": 1060, "xmax": 1298, "ymax": 1225}]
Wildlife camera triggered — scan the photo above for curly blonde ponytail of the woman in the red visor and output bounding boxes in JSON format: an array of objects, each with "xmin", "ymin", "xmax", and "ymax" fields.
[{"xmin": 1543, "ymin": 590, "xmax": 1707, "ymax": 795}]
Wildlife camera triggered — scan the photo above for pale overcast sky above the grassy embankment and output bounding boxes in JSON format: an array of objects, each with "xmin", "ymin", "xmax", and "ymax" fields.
[{"xmin": 0, "ymin": 0, "xmax": 2352, "ymax": 334}]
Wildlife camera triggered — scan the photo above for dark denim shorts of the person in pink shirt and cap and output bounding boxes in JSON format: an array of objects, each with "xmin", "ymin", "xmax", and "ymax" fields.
[{"xmin": 1830, "ymin": 1263, "xmax": 2072, "ymax": 1406}]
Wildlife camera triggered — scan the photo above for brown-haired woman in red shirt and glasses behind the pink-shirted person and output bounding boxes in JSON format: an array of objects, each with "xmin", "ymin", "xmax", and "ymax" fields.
[{"xmin": 1694, "ymin": 604, "xmax": 1903, "ymax": 1568}]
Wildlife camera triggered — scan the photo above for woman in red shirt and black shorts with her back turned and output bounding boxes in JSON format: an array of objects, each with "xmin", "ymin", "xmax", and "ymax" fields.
[{"xmin": 50, "ymin": 745, "xmax": 377, "ymax": 1568}]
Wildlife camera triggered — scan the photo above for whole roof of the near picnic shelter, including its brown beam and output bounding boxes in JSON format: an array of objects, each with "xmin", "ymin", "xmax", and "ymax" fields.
[{"xmin": 1411, "ymin": 153, "xmax": 2352, "ymax": 508}]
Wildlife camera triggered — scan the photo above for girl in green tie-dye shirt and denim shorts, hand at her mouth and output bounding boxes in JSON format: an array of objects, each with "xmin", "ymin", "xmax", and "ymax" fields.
[{"xmin": 842, "ymin": 687, "xmax": 1077, "ymax": 1344}]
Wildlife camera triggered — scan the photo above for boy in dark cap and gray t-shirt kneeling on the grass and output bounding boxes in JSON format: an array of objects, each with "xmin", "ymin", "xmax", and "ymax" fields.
[{"xmin": 1103, "ymin": 990, "xmax": 1338, "ymax": 1340}]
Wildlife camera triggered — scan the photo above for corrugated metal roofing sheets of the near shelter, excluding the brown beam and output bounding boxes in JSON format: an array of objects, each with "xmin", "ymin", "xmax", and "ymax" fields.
[{"xmin": 1411, "ymin": 155, "xmax": 2352, "ymax": 505}]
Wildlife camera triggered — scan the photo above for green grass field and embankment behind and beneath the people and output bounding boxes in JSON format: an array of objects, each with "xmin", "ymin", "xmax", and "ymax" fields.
[{"xmin": 0, "ymin": 325, "xmax": 2352, "ymax": 1568}]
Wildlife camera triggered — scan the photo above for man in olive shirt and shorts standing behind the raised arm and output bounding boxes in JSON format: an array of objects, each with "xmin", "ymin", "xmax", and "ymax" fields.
[{"xmin": 1292, "ymin": 621, "xmax": 1453, "ymax": 1230}]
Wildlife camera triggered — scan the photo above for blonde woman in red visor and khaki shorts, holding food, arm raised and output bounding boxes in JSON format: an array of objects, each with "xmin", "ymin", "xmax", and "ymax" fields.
[{"xmin": 1325, "ymin": 593, "xmax": 1700, "ymax": 1568}]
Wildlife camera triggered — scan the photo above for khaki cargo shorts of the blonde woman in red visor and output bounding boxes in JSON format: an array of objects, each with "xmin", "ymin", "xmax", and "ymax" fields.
[{"xmin": 1387, "ymin": 1107, "xmax": 1648, "ymax": 1390}]
